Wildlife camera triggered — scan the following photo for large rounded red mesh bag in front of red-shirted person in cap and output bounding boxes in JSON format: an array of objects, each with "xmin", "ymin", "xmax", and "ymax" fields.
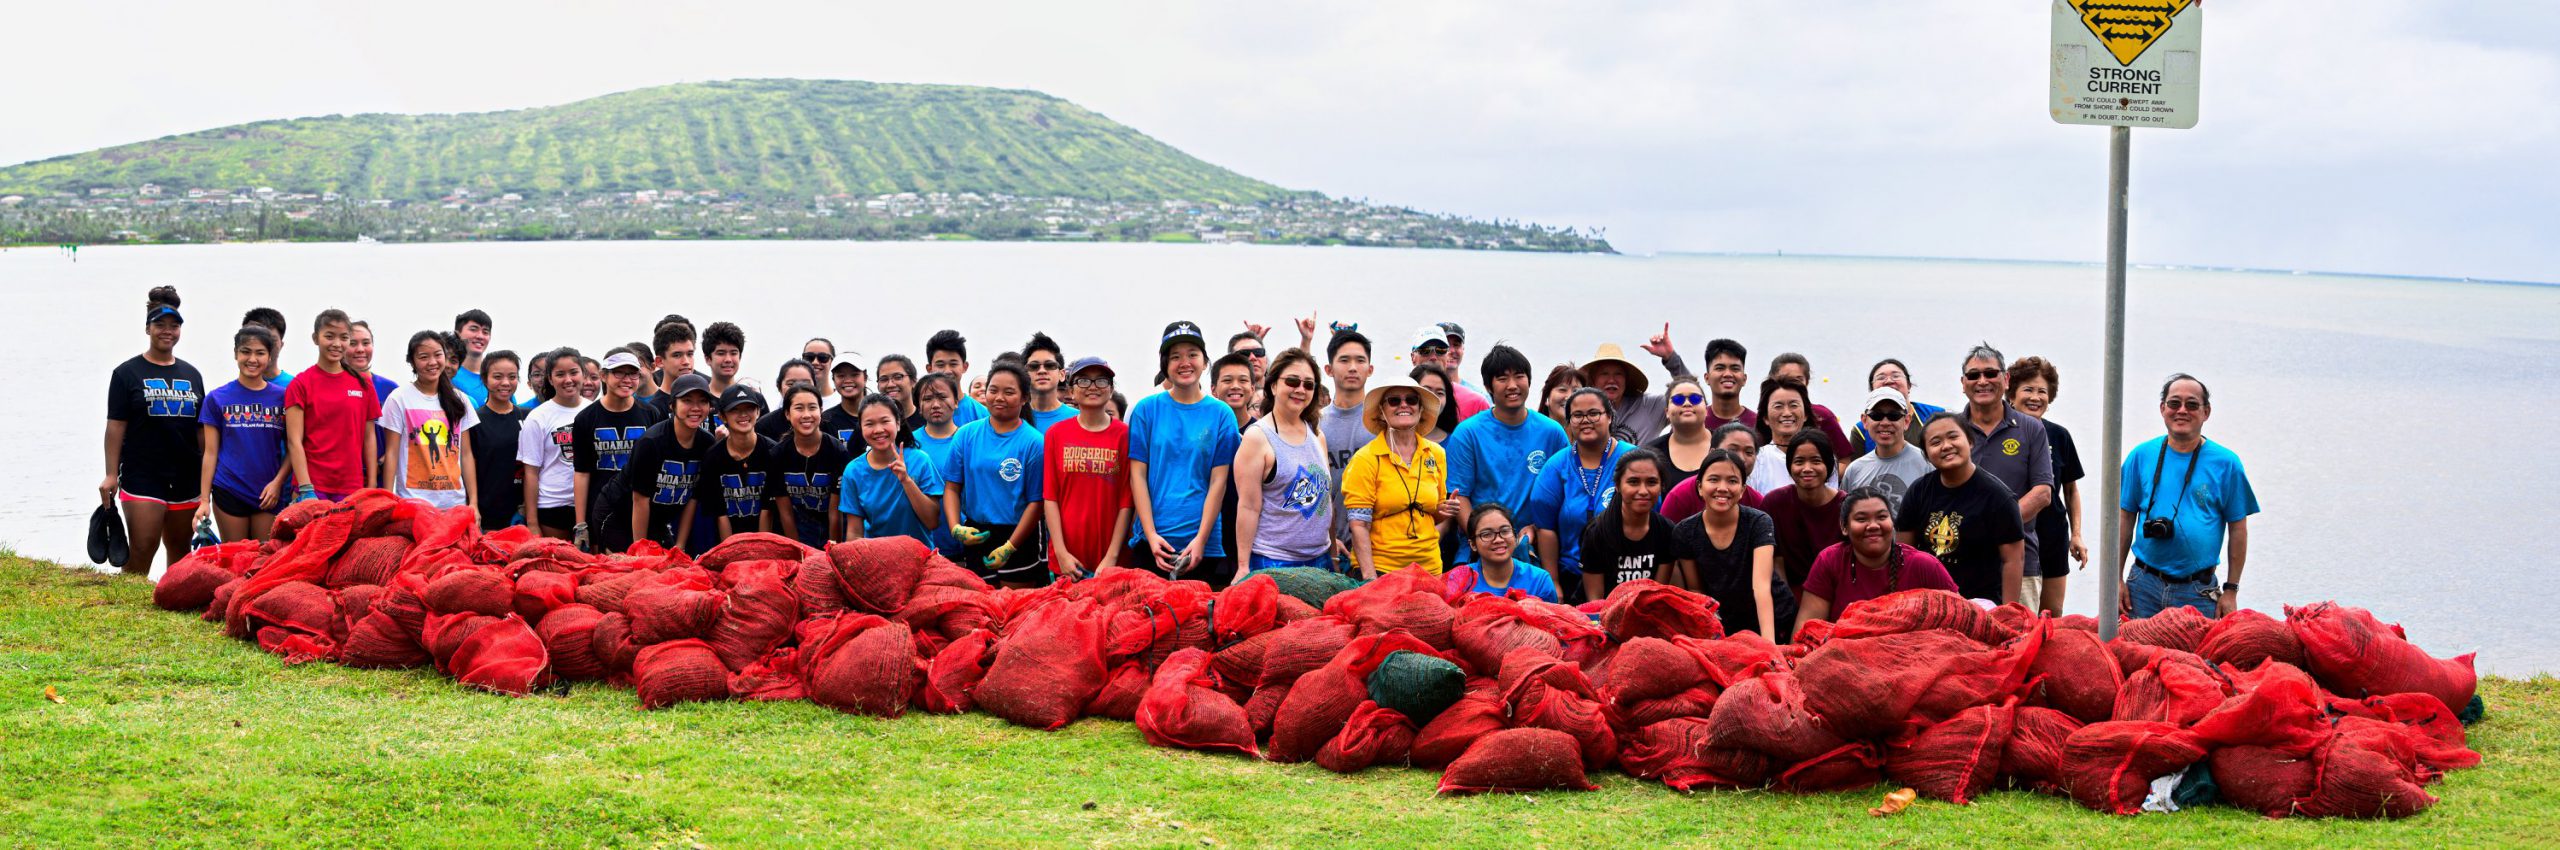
[{"xmin": 978, "ymin": 602, "xmax": 1108, "ymax": 730}]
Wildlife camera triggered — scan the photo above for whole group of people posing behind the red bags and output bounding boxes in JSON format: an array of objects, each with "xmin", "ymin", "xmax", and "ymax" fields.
[{"xmin": 97, "ymin": 287, "xmax": 2258, "ymax": 643}]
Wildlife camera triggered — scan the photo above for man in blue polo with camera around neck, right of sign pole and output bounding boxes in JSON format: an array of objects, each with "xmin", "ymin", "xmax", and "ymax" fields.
[{"xmin": 2117, "ymin": 371, "xmax": 2258, "ymax": 617}]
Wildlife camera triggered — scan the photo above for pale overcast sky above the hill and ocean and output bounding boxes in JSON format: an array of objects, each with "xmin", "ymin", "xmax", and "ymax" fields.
[{"xmin": 0, "ymin": 0, "xmax": 2560, "ymax": 282}]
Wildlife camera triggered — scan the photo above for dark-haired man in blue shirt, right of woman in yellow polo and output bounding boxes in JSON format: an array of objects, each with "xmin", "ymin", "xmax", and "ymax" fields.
[{"xmin": 1449, "ymin": 343, "xmax": 1569, "ymax": 563}]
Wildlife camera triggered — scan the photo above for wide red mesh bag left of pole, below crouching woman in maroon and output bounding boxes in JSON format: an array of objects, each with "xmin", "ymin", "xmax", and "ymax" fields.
[{"xmin": 1795, "ymin": 627, "xmax": 2040, "ymax": 737}]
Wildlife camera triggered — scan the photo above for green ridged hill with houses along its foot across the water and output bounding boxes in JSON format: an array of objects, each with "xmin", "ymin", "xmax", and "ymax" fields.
[{"xmin": 0, "ymin": 79, "xmax": 1610, "ymax": 251}]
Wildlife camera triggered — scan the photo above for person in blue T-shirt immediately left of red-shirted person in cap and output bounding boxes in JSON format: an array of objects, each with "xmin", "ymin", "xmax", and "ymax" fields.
[{"xmin": 942, "ymin": 361, "xmax": 1050, "ymax": 586}]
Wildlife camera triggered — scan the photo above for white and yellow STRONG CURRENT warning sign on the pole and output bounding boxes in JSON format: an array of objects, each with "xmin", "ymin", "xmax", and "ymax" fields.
[{"xmin": 2051, "ymin": 0, "xmax": 2204, "ymax": 131}]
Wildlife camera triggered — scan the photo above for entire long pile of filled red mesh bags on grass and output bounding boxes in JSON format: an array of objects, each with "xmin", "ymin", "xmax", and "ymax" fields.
[{"xmin": 154, "ymin": 492, "xmax": 2481, "ymax": 817}]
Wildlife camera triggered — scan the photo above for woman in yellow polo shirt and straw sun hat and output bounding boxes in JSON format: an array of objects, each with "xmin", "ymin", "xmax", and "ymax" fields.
[{"xmin": 1341, "ymin": 369, "xmax": 1459, "ymax": 581}]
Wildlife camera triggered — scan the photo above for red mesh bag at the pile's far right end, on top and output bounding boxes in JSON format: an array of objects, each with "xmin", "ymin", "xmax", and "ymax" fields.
[{"xmin": 2284, "ymin": 602, "xmax": 2481, "ymax": 712}]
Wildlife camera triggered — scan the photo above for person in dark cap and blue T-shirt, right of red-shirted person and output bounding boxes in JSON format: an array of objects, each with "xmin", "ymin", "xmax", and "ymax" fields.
[{"xmin": 1129, "ymin": 323, "xmax": 1236, "ymax": 579}]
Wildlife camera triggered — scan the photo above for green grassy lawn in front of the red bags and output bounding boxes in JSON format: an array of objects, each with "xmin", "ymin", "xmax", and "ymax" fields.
[{"xmin": 0, "ymin": 556, "xmax": 2560, "ymax": 847}]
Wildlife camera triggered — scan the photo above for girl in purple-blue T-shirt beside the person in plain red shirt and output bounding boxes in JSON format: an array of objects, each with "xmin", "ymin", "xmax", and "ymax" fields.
[{"xmin": 197, "ymin": 325, "xmax": 292, "ymax": 540}]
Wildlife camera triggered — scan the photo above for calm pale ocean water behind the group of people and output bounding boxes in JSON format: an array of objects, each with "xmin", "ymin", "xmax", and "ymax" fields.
[{"xmin": 0, "ymin": 243, "xmax": 2560, "ymax": 673}]
